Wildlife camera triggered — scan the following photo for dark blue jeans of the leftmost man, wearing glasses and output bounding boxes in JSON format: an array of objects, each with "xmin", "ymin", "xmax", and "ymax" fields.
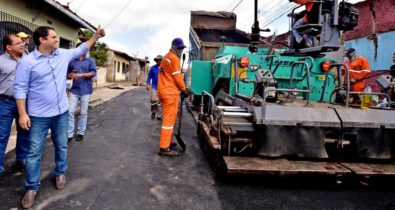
[{"xmin": 0, "ymin": 96, "xmax": 29, "ymax": 173}]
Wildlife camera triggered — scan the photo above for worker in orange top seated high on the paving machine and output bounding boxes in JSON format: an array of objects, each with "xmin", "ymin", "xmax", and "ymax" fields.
[{"xmin": 289, "ymin": 0, "xmax": 315, "ymax": 47}]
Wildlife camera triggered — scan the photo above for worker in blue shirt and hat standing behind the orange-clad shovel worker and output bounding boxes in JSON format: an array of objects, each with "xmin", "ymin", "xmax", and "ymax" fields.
[{"xmin": 146, "ymin": 55, "xmax": 162, "ymax": 120}]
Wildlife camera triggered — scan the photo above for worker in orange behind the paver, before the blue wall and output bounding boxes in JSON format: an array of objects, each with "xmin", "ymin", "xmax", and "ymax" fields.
[{"xmin": 345, "ymin": 48, "xmax": 370, "ymax": 102}]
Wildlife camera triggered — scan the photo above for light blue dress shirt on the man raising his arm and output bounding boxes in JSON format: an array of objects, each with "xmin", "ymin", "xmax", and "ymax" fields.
[{"xmin": 14, "ymin": 43, "xmax": 89, "ymax": 117}]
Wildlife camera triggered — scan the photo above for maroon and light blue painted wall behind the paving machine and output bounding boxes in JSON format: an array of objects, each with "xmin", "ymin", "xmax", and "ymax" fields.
[{"xmin": 345, "ymin": 0, "xmax": 395, "ymax": 70}]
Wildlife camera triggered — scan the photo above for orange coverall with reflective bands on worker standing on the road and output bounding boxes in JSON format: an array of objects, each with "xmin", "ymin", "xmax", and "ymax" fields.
[{"xmin": 158, "ymin": 50, "xmax": 186, "ymax": 149}]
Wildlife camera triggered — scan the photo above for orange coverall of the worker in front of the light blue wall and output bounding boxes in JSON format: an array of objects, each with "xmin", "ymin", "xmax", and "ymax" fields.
[{"xmin": 345, "ymin": 55, "xmax": 370, "ymax": 92}]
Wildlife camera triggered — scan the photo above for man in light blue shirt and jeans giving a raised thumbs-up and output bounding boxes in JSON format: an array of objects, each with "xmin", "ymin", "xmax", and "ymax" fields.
[{"xmin": 14, "ymin": 26, "xmax": 105, "ymax": 208}]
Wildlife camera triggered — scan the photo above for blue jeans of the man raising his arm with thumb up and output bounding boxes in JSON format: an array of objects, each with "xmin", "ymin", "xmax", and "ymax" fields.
[{"xmin": 25, "ymin": 112, "xmax": 68, "ymax": 191}]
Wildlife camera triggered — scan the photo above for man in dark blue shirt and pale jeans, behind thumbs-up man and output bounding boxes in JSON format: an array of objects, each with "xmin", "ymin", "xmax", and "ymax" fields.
[{"xmin": 67, "ymin": 42, "xmax": 96, "ymax": 141}]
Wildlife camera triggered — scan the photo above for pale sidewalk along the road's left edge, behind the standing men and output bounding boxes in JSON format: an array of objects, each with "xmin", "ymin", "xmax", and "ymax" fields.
[{"xmin": 5, "ymin": 82, "xmax": 138, "ymax": 154}]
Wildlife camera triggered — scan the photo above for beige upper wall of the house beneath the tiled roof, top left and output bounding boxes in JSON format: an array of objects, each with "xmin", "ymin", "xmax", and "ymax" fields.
[{"xmin": 0, "ymin": 0, "xmax": 79, "ymax": 45}]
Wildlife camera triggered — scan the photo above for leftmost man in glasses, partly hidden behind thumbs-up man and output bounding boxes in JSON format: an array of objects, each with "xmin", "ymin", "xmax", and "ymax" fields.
[{"xmin": 0, "ymin": 34, "xmax": 29, "ymax": 174}]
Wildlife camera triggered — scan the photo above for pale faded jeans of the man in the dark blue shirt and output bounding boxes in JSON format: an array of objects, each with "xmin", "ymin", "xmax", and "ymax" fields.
[{"xmin": 68, "ymin": 93, "xmax": 91, "ymax": 138}]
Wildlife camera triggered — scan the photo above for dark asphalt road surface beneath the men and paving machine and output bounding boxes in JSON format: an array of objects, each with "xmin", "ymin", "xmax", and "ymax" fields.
[{"xmin": 0, "ymin": 88, "xmax": 395, "ymax": 210}]
